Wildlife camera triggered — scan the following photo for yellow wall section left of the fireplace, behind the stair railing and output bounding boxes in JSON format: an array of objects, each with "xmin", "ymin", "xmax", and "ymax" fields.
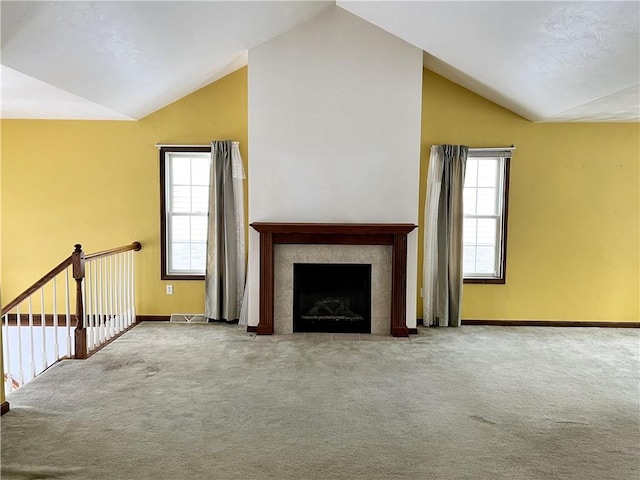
[{"xmin": 1, "ymin": 68, "xmax": 247, "ymax": 315}]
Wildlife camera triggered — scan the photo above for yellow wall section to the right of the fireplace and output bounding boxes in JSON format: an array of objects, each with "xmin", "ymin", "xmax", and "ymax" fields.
[{"xmin": 418, "ymin": 70, "xmax": 640, "ymax": 322}]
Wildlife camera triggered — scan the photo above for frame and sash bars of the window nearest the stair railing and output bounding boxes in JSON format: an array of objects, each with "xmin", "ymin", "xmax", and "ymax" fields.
[{"xmin": 160, "ymin": 147, "xmax": 211, "ymax": 280}]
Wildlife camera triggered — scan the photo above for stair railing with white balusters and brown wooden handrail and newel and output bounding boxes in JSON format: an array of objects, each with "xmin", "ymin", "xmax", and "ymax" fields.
[{"xmin": 1, "ymin": 242, "xmax": 142, "ymax": 393}]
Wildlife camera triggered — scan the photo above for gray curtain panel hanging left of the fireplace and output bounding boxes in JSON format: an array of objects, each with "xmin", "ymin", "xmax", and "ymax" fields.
[{"xmin": 205, "ymin": 140, "xmax": 245, "ymax": 322}]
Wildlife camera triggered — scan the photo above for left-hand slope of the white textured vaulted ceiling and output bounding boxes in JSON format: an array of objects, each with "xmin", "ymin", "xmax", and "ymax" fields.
[{"xmin": 1, "ymin": 1, "xmax": 331, "ymax": 119}]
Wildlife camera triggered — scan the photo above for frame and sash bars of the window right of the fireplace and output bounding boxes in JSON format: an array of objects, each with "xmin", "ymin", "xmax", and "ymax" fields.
[{"xmin": 463, "ymin": 149, "xmax": 511, "ymax": 284}]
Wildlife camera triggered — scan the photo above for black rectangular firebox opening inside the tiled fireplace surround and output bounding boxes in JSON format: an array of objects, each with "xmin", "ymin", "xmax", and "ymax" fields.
[{"xmin": 293, "ymin": 263, "xmax": 371, "ymax": 333}]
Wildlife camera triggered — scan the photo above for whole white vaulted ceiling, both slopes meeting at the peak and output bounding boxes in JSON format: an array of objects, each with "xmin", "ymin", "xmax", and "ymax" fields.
[{"xmin": 0, "ymin": 1, "xmax": 640, "ymax": 121}]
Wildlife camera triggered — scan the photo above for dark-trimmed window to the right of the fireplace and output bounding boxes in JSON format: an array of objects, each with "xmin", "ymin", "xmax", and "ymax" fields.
[{"xmin": 462, "ymin": 150, "xmax": 511, "ymax": 283}]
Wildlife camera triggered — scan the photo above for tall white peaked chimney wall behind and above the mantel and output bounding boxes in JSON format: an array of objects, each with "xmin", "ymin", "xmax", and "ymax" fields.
[{"xmin": 249, "ymin": 7, "xmax": 422, "ymax": 327}]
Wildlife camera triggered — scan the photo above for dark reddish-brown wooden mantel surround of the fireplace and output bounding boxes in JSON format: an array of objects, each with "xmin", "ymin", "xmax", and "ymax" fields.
[{"xmin": 251, "ymin": 222, "xmax": 417, "ymax": 337}]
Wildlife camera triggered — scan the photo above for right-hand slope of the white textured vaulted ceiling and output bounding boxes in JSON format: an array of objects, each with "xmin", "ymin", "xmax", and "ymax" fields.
[{"xmin": 338, "ymin": 1, "xmax": 640, "ymax": 121}]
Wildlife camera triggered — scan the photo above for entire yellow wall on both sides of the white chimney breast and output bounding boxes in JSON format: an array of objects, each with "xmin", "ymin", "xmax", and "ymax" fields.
[{"xmin": 1, "ymin": 65, "xmax": 640, "ymax": 321}]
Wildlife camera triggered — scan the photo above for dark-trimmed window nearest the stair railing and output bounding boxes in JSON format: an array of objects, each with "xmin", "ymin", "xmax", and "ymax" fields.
[{"xmin": 160, "ymin": 147, "xmax": 211, "ymax": 280}]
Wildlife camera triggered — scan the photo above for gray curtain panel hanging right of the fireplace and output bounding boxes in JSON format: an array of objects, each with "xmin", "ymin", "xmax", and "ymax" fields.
[{"xmin": 423, "ymin": 145, "xmax": 469, "ymax": 327}]
